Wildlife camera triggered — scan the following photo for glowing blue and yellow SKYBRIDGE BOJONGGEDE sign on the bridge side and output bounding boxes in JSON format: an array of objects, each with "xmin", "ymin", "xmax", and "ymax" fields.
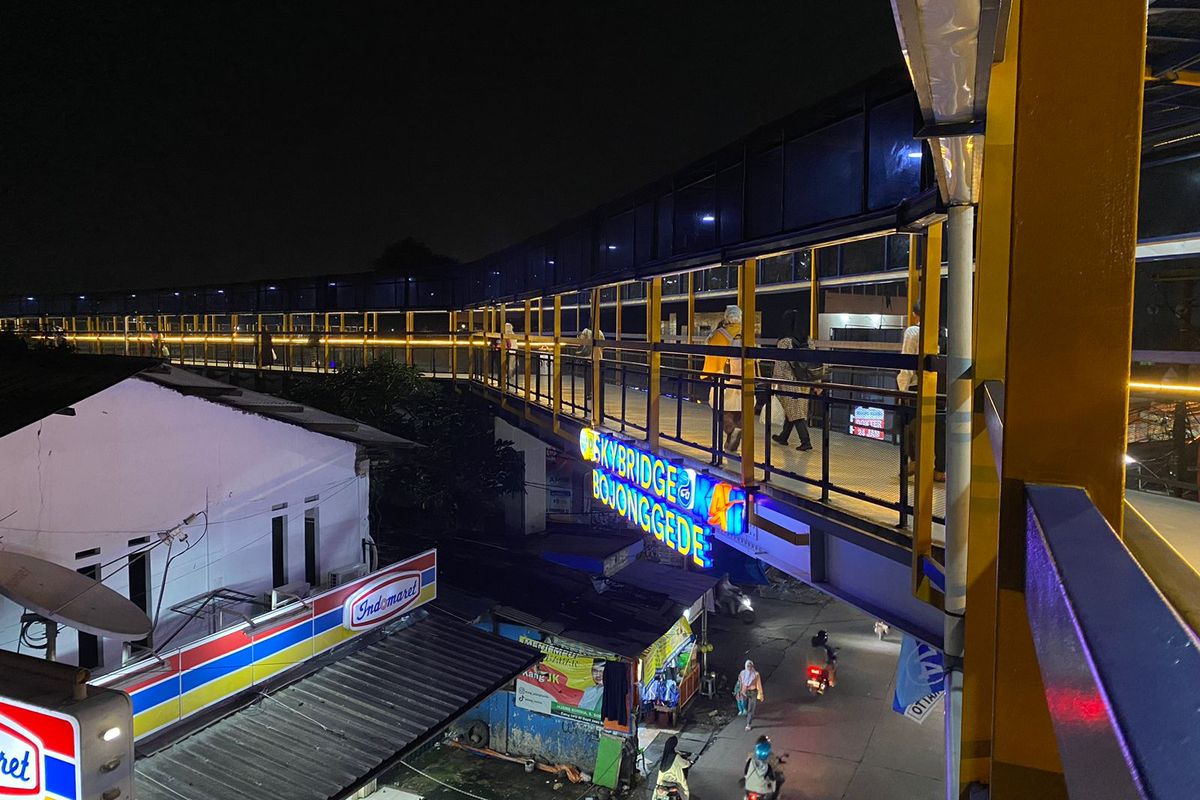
[{"xmin": 580, "ymin": 428, "xmax": 746, "ymax": 567}]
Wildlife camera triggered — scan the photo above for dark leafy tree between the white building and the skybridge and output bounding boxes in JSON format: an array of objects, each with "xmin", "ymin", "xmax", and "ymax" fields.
[{"xmin": 289, "ymin": 361, "xmax": 524, "ymax": 527}]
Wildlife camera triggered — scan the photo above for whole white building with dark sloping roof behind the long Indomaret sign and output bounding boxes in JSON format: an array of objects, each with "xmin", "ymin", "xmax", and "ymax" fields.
[{"xmin": 0, "ymin": 356, "xmax": 415, "ymax": 673}]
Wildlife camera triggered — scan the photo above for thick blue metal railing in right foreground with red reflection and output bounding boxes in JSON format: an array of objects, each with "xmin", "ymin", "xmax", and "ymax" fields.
[{"xmin": 1025, "ymin": 486, "xmax": 1200, "ymax": 799}]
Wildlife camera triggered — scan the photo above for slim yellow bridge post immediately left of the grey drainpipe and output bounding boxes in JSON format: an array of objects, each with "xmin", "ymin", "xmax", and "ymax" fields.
[{"xmin": 900, "ymin": 222, "xmax": 942, "ymax": 606}]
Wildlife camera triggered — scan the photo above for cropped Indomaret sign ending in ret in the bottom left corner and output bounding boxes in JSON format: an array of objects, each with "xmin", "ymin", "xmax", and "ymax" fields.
[{"xmin": 0, "ymin": 698, "xmax": 82, "ymax": 800}]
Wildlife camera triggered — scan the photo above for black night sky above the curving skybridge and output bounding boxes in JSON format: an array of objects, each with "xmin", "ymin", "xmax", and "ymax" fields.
[{"xmin": 0, "ymin": 0, "xmax": 900, "ymax": 291}]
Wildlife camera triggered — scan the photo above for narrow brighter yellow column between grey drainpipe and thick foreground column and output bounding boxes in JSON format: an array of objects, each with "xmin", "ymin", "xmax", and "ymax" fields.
[{"xmin": 960, "ymin": 0, "xmax": 1020, "ymax": 793}]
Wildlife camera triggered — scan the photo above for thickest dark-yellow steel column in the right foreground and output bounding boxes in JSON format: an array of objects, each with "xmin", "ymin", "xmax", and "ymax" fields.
[{"xmin": 988, "ymin": 0, "xmax": 1147, "ymax": 800}]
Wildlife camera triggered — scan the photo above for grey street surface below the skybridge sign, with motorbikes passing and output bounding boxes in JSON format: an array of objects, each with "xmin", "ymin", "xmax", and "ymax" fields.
[{"xmin": 676, "ymin": 591, "xmax": 944, "ymax": 800}]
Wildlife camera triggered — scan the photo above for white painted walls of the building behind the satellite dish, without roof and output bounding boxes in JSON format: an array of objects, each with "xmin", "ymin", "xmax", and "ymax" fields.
[{"xmin": 0, "ymin": 378, "xmax": 370, "ymax": 672}]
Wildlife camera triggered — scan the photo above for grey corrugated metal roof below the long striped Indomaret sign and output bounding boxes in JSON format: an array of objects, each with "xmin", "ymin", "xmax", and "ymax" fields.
[{"xmin": 136, "ymin": 613, "xmax": 540, "ymax": 800}]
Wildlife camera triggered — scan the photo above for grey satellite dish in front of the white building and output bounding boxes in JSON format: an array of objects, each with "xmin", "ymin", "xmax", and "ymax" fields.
[{"xmin": 0, "ymin": 552, "xmax": 151, "ymax": 642}]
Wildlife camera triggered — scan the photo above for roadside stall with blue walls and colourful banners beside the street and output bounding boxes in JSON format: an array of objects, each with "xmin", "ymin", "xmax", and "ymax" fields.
[{"xmin": 436, "ymin": 542, "xmax": 716, "ymax": 788}]
